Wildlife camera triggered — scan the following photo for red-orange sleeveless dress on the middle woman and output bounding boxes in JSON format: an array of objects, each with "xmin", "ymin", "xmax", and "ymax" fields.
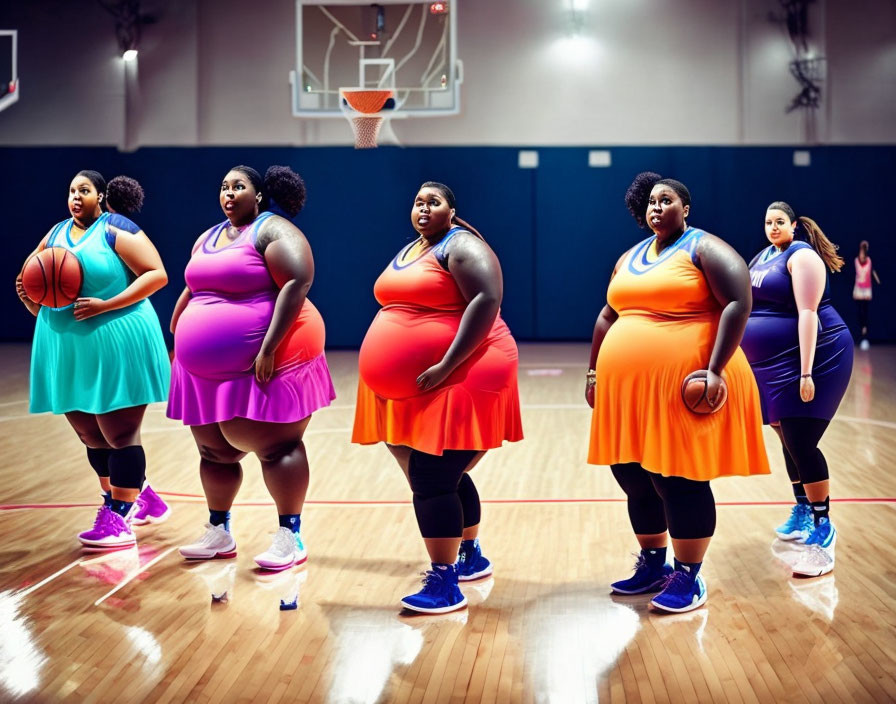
[{"xmin": 352, "ymin": 228, "xmax": 523, "ymax": 455}]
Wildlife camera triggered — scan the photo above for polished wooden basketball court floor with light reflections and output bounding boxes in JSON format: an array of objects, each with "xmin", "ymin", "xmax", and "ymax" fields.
[{"xmin": 0, "ymin": 345, "xmax": 896, "ymax": 703}]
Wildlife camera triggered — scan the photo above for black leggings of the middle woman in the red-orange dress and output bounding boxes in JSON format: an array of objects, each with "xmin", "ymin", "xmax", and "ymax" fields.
[{"xmin": 408, "ymin": 450, "xmax": 481, "ymax": 538}]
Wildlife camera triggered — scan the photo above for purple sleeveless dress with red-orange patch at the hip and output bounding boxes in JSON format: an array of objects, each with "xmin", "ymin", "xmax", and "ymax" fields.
[{"xmin": 168, "ymin": 213, "xmax": 336, "ymax": 425}]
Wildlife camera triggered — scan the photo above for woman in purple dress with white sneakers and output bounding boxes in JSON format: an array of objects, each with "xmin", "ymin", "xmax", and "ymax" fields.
[{"xmin": 168, "ymin": 166, "xmax": 335, "ymax": 570}]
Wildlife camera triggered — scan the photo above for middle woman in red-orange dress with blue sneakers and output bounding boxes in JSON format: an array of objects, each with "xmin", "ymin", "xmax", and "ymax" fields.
[{"xmin": 352, "ymin": 181, "xmax": 523, "ymax": 613}]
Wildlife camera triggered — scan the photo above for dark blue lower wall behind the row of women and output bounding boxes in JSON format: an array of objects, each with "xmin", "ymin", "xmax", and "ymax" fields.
[{"xmin": 0, "ymin": 145, "xmax": 896, "ymax": 347}]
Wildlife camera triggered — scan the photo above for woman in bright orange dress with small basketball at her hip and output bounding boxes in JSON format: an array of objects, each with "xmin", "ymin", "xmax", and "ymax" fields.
[{"xmin": 585, "ymin": 172, "xmax": 769, "ymax": 612}]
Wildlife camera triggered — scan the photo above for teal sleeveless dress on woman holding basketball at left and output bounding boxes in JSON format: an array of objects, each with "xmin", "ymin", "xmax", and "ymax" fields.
[{"xmin": 29, "ymin": 213, "xmax": 171, "ymax": 414}]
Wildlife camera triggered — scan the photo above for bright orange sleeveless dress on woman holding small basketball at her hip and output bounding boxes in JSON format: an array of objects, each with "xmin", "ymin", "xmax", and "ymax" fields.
[{"xmin": 588, "ymin": 228, "xmax": 769, "ymax": 481}]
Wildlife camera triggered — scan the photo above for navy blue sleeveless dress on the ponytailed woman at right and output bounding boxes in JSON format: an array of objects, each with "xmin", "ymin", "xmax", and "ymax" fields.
[{"xmin": 741, "ymin": 240, "xmax": 853, "ymax": 423}]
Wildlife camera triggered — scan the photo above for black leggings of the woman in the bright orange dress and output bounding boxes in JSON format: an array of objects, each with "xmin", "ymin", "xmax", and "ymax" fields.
[{"xmin": 610, "ymin": 462, "xmax": 716, "ymax": 540}]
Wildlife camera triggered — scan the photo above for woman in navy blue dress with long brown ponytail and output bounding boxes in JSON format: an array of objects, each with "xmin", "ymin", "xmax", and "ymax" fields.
[{"xmin": 741, "ymin": 201, "xmax": 853, "ymax": 576}]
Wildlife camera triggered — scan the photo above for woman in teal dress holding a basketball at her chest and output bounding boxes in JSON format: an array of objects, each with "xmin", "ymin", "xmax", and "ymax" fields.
[{"xmin": 16, "ymin": 171, "xmax": 170, "ymax": 548}]
